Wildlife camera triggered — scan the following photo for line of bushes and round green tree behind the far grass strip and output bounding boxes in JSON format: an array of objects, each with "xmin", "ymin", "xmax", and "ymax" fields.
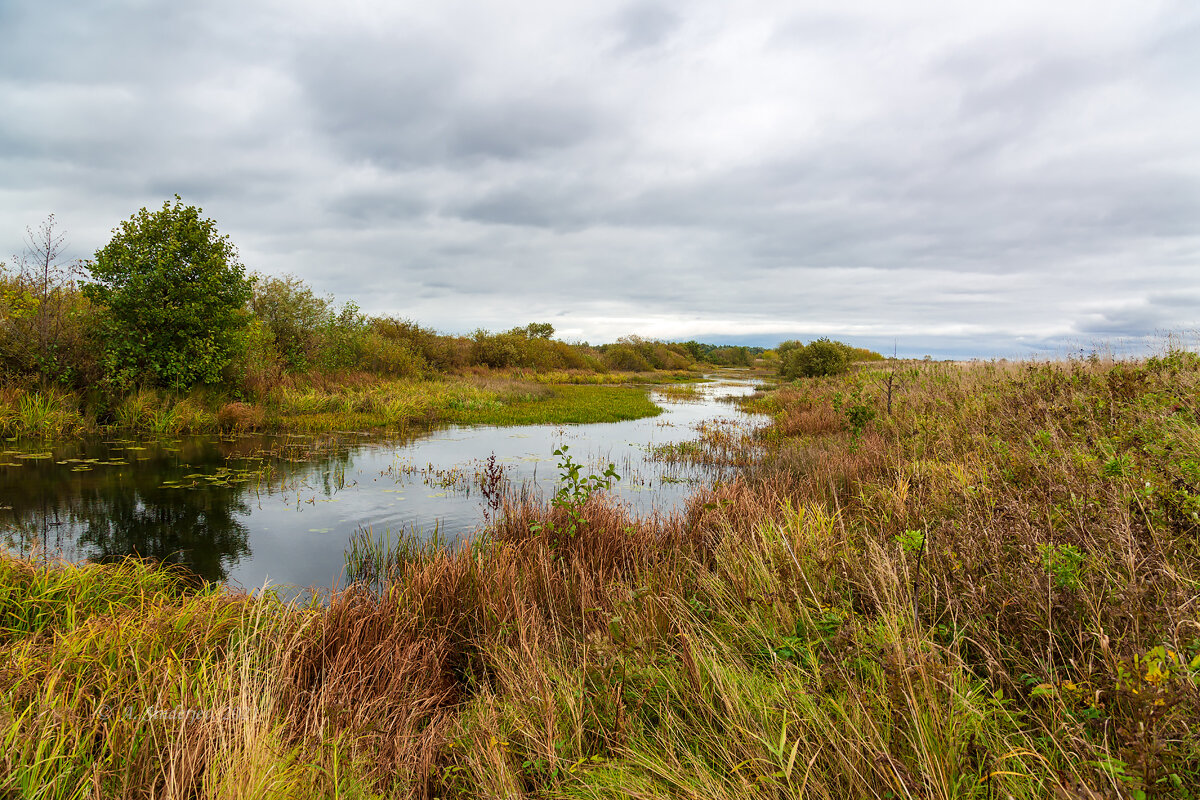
[{"xmin": 0, "ymin": 198, "xmax": 878, "ymax": 399}]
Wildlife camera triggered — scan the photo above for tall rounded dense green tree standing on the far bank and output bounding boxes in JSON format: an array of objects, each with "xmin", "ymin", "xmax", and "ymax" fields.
[{"xmin": 84, "ymin": 194, "xmax": 251, "ymax": 389}]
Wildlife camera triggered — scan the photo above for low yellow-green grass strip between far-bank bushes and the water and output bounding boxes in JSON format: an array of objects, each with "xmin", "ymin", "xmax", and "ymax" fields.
[{"xmin": 0, "ymin": 373, "xmax": 672, "ymax": 438}]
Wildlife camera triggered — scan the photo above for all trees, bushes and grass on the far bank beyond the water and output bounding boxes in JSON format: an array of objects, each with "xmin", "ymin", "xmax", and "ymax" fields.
[{"xmin": 0, "ymin": 198, "xmax": 748, "ymax": 438}]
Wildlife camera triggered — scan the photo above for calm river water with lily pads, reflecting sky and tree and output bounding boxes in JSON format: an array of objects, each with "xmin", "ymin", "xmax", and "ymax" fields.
[{"xmin": 0, "ymin": 380, "xmax": 762, "ymax": 589}]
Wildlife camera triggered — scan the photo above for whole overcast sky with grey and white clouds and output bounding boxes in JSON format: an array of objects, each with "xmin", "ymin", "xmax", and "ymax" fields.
[{"xmin": 0, "ymin": 0, "xmax": 1200, "ymax": 356}]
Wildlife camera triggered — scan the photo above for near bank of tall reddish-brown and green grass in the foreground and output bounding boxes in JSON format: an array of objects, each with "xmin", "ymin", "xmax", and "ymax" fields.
[{"xmin": 0, "ymin": 353, "xmax": 1200, "ymax": 800}]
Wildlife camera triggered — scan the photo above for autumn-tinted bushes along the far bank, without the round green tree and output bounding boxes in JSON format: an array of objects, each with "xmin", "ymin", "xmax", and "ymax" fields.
[{"xmin": 0, "ymin": 262, "xmax": 720, "ymax": 393}]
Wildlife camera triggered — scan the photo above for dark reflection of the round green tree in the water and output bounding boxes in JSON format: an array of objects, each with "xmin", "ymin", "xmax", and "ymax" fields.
[{"xmin": 78, "ymin": 487, "xmax": 250, "ymax": 582}]
